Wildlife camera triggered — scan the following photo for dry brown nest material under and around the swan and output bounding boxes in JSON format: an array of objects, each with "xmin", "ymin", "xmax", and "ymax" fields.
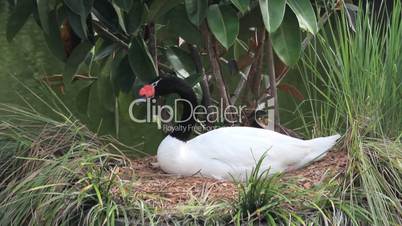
[{"xmin": 114, "ymin": 151, "xmax": 347, "ymax": 209}]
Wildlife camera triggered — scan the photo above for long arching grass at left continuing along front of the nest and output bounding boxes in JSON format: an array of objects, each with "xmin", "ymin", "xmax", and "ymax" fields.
[{"xmin": 0, "ymin": 100, "xmax": 370, "ymax": 225}]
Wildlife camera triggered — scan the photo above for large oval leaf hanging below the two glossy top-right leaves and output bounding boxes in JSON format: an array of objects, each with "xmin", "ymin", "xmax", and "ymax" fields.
[{"xmin": 271, "ymin": 11, "xmax": 301, "ymax": 66}]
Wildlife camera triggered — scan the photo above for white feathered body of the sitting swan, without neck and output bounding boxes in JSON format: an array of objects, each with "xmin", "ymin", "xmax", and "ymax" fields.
[{"xmin": 157, "ymin": 127, "xmax": 340, "ymax": 181}]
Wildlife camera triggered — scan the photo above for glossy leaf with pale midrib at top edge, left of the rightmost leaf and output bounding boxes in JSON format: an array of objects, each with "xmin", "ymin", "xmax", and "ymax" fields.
[{"xmin": 259, "ymin": 0, "xmax": 286, "ymax": 33}]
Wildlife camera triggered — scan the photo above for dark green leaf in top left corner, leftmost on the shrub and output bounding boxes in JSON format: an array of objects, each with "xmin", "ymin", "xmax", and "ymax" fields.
[{"xmin": 7, "ymin": 0, "xmax": 34, "ymax": 41}]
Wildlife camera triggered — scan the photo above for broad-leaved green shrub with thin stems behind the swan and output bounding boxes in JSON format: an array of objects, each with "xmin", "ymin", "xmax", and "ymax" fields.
[{"xmin": 7, "ymin": 0, "xmax": 336, "ymax": 148}]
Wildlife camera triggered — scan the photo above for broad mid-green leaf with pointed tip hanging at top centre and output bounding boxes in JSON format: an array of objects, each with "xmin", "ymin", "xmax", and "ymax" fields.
[{"xmin": 207, "ymin": 4, "xmax": 239, "ymax": 49}]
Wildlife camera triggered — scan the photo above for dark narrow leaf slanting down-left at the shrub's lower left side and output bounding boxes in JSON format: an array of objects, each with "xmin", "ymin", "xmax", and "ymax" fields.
[{"xmin": 63, "ymin": 41, "xmax": 92, "ymax": 79}]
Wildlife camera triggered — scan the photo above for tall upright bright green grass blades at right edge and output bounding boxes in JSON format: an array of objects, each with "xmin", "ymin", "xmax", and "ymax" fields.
[{"xmin": 301, "ymin": 1, "xmax": 402, "ymax": 138}]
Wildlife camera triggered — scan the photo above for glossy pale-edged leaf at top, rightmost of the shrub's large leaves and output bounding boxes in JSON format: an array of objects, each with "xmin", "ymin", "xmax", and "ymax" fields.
[{"xmin": 287, "ymin": 0, "xmax": 318, "ymax": 34}]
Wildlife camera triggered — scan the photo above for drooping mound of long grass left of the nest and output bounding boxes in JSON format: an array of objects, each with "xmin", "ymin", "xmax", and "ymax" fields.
[{"xmin": 0, "ymin": 105, "xmax": 141, "ymax": 225}]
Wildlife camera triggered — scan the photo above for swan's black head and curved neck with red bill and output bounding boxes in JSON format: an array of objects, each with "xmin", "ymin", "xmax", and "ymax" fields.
[{"xmin": 139, "ymin": 76, "xmax": 197, "ymax": 141}]
